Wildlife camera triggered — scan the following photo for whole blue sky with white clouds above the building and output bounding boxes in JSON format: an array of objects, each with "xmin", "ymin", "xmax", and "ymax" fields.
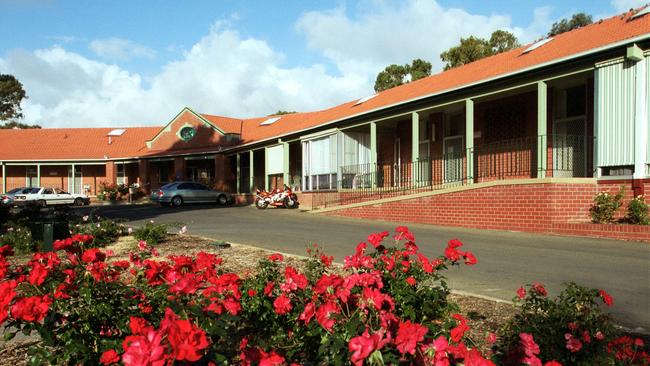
[{"xmin": 0, "ymin": 0, "xmax": 646, "ymax": 127}]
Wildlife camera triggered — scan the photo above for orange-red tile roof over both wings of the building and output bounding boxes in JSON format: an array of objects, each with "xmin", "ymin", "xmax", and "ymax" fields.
[{"xmin": 0, "ymin": 7, "xmax": 650, "ymax": 160}]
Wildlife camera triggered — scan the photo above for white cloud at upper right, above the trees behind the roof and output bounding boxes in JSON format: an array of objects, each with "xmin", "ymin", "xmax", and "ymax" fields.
[{"xmin": 296, "ymin": 0, "xmax": 550, "ymax": 79}]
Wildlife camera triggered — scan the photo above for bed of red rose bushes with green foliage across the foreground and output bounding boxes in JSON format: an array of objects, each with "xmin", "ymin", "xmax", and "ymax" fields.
[{"xmin": 0, "ymin": 227, "xmax": 643, "ymax": 365}]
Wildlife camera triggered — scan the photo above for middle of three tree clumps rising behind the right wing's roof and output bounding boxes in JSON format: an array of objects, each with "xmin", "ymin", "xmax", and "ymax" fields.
[{"xmin": 440, "ymin": 30, "xmax": 519, "ymax": 70}]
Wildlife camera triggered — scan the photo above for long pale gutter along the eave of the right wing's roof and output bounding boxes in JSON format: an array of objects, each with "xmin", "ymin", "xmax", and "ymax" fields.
[{"xmin": 221, "ymin": 33, "xmax": 650, "ymax": 152}]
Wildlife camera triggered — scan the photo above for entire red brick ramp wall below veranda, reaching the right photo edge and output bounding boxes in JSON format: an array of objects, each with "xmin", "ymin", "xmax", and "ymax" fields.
[{"xmin": 320, "ymin": 181, "xmax": 650, "ymax": 241}]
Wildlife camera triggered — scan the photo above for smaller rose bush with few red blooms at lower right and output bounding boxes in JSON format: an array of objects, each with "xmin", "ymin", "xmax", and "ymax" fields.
[{"xmin": 496, "ymin": 283, "xmax": 615, "ymax": 365}]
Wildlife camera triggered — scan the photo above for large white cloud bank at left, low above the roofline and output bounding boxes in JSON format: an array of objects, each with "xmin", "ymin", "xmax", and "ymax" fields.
[{"xmin": 0, "ymin": 28, "xmax": 368, "ymax": 127}]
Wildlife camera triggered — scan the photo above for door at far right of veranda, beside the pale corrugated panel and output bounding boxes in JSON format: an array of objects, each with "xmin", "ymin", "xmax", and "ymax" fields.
[{"xmin": 553, "ymin": 117, "xmax": 587, "ymax": 177}]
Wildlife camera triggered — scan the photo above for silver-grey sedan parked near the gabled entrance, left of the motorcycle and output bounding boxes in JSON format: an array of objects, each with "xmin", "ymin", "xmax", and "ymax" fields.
[{"xmin": 149, "ymin": 181, "xmax": 234, "ymax": 207}]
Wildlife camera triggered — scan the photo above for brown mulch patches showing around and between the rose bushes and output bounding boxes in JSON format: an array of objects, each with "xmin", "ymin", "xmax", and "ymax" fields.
[{"xmin": 0, "ymin": 234, "xmax": 515, "ymax": 366}]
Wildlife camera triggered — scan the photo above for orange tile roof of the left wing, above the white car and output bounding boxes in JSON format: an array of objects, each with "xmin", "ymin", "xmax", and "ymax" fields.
[{"xmin": 0, "ymin": 127, "xmax": 161, "ymax": 161}]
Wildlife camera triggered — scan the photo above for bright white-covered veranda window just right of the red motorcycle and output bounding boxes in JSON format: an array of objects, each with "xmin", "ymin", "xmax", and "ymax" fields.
[{"xmin": 302, "ymin": 135, "xmax": 338, "ymax": 190}]
